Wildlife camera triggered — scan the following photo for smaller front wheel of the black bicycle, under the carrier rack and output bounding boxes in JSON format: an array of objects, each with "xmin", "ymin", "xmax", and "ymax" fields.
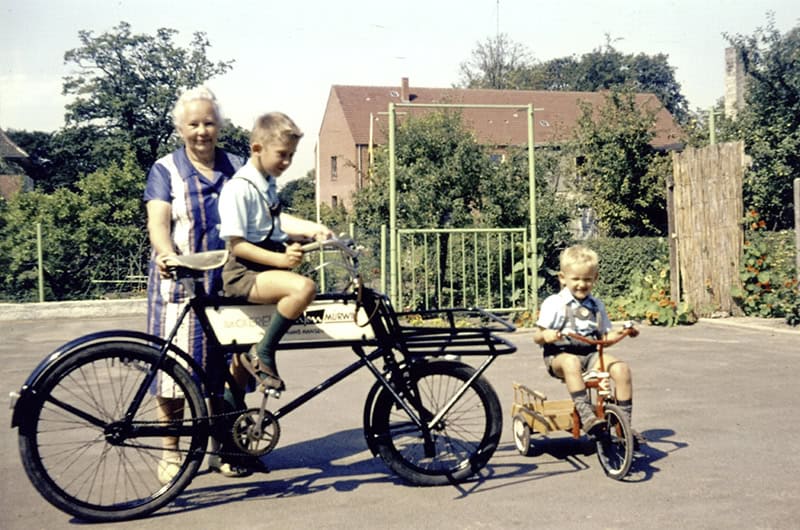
[{"xmin": 371, "ymin": 361, "xmax": 503, "ymax": 486}]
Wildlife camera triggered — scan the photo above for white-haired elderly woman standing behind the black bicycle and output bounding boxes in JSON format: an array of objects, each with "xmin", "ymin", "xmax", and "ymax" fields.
[{"xmin": 144, "ymin": 86, "xmax": 249, "ymax": 483}]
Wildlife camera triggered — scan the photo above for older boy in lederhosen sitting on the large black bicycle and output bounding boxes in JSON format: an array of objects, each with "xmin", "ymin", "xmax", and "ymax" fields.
[{"xmin": 219, "ymin": 112, "xmax": 332, "ymax": 391}]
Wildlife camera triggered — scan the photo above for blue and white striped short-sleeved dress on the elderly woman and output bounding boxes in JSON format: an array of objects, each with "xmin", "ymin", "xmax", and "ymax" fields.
[{"xmin": 144, "ymin": 147, "xmax": 245, "ymax": 397}]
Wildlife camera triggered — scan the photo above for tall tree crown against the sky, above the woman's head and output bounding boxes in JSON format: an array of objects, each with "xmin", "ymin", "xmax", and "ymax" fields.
[{"xmin": 63, "ymin": 22, "xmax": 233, "ymax": 168}]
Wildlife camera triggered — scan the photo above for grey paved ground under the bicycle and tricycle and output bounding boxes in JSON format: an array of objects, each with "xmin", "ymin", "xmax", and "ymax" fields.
[{"xmin": 0, "ymin": 317, "xmax": 800, "ymax": 530}]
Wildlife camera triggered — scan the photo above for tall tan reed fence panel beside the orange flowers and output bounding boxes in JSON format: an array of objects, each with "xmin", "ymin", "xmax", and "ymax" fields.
[{"xmin": 669, "ymin": 142, "xmax": 745, "ymax": 316}]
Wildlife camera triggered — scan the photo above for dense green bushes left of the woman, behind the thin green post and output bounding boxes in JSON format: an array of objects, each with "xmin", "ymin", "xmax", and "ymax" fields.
[{"xmin": 0, "ymin": 153, "xmax": 148, "ymax": 301}]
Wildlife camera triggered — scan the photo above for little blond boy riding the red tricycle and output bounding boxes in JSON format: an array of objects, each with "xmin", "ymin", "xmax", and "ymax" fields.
[{"xmin": 533, "ymin": 245, "xmax": 646, "ymax": 446}]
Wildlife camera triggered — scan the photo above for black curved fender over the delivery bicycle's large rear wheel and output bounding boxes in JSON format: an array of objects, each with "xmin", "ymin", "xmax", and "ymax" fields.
[{"xmin": 11, "ymin": 330, "xmax": 202, "ymax": 428}]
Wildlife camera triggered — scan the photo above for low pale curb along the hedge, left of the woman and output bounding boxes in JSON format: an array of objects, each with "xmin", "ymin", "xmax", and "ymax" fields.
[{"xmin": 0, "ymin": 298, "xmax": 147, "ymax": 321}]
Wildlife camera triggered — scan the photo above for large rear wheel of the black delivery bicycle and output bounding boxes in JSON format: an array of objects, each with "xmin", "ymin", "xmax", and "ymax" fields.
[{"xmin": 19, "ymin": 341, "xmax": 208, "ymax": 522}]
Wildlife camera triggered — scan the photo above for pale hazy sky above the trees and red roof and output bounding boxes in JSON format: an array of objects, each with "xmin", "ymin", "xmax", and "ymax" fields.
[{"xmin": 0, "ymin": 0, "xmax": 800, "ymax": 180}]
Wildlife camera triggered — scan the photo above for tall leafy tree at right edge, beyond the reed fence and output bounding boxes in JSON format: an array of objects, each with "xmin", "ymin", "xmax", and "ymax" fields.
[{"xmin": 725, "ymin": 15, "xmax": 800, "ymax": 229}]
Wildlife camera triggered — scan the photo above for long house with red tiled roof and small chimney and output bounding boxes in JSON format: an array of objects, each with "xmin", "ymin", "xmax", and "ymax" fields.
[{"xmin": 317, "ymin": 77, "xmax": 683, "ymax": 208}]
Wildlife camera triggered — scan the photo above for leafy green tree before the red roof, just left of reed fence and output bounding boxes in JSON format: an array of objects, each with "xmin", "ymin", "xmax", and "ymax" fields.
[{"xmin": 573, "ymin": 90, "xmax": 671, "ymax": 237}]
